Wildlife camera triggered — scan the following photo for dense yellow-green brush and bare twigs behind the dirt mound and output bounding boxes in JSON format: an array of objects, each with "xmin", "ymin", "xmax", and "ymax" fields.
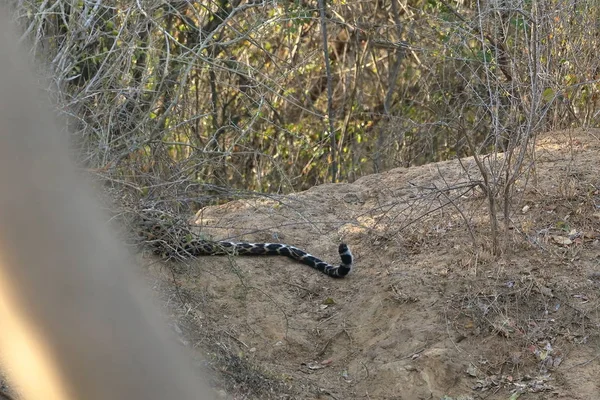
[{"xmin": 12, "ymin": 0, "xmax": 600, "ymax": 200}]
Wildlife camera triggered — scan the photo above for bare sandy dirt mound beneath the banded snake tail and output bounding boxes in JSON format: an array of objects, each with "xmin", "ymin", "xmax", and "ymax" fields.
[{"xmin": 145, "ymin": 130, "xmax": 600, "ymax": 399}]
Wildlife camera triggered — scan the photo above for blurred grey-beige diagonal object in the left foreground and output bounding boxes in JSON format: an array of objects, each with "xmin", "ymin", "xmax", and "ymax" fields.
[{"xmin": 0, "ymin": 8, "xmax": 212, "ymax": 400}]
